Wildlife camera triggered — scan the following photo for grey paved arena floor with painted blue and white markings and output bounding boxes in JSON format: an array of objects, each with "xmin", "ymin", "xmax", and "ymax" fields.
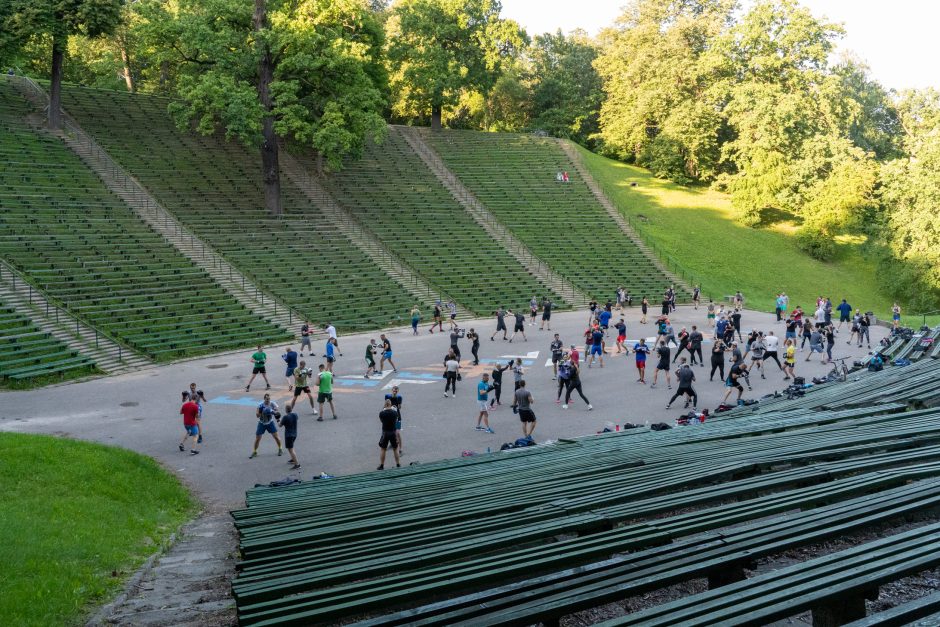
[{"xmin": 0, "ymin": 306, "xmax": 887, "ymax": 507}]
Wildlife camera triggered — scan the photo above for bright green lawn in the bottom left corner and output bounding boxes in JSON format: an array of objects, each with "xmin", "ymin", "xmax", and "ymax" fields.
[{"xmin": 0, "ymin": 433, "xmax": 196, "ymax": 625}]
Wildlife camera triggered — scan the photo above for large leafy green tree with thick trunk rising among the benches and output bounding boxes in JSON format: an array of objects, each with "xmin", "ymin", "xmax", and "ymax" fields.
[{"xmin": 146, "ymin": 0, "xmax": 385, "ymax": 214}]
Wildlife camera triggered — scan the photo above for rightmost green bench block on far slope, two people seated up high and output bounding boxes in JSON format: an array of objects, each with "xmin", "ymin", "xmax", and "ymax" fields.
[{"xmin": 425, "ymin": 131, "xmax": 669, "ymax": 301}]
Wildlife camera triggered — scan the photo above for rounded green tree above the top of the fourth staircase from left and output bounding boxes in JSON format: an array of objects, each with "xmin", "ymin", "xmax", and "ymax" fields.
[{"xmin": 387, "ymin": 0, "xmax": 525, "ymax": 129}]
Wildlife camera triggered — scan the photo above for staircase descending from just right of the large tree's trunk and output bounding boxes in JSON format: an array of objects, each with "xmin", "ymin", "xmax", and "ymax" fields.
[{"xmin": 279, "ymin": 150, "xmax": 470, "ymax": 311}]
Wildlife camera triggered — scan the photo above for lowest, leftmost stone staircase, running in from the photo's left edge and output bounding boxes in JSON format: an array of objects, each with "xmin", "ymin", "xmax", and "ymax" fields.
[{"xmin": 0, "ymin": 261, "xmax": 153, "ymax": 374}]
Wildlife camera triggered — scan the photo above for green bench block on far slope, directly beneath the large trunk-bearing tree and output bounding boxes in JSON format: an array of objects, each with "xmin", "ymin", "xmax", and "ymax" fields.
[{"xmin": 63, "ymin": 86, "xmax": 420, "ymax": 330}]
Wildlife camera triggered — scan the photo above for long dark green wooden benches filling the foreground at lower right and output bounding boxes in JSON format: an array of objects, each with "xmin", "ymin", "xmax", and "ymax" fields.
[{"xmin": 233, "ymin": 360, "xmax": 940, "ymax": 626}]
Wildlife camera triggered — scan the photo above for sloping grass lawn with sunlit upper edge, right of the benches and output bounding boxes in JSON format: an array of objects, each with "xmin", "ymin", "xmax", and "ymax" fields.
[{"xmin": 579, "ymin": 147, "xmax": 940, "ymax": 328}]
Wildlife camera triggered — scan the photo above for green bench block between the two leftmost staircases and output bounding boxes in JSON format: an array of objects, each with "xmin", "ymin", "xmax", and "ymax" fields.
[{"xmin": 0, "ymin": 82, "xmax": 285, "ymax": 360}]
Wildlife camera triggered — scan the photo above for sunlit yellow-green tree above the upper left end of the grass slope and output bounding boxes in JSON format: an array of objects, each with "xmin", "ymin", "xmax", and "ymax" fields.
[{"xmin": 594, "ymin": 0, "xmax": 735, "ymax": 181}]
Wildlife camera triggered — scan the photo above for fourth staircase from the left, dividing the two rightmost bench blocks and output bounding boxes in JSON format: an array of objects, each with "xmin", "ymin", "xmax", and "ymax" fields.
[{"xmin": 389, "ymin": 126, "xmax": 590, "ymax": 307}]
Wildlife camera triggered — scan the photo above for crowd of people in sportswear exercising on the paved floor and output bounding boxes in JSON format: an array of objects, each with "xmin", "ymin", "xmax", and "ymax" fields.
[{"xmin": 179, "ymin": 286, "xmax": 901, "ymax": 470}]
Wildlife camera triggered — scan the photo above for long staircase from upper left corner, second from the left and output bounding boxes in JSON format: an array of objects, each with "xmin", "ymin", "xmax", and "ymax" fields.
[{"xmin": 12, "ymin": 77, "xmax": 302, "ymax": 335}]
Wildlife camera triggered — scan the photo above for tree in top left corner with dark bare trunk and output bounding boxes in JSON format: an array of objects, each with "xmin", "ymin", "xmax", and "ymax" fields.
[{"xmin": 0, "ymin": 0, "xmax": 124, "ymax": 129}]
